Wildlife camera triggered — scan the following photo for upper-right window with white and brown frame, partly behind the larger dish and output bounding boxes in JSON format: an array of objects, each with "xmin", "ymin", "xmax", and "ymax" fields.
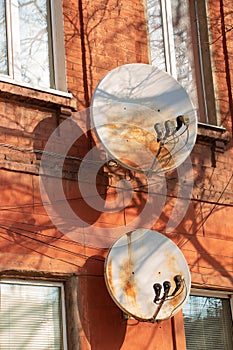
[{"xmin": 147, "ymin": 0, "xmax": 217, "ymax": 125}]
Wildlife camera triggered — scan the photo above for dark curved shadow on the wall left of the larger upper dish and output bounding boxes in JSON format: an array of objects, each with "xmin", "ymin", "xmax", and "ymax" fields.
[{"xmin": 34, "ymin": 116, "xmax": 107, "ymax": 233}]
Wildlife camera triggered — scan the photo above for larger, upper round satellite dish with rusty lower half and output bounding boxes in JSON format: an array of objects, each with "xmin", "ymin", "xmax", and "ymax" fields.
[{"xmin": 91, "ymin": 63, "xmax": 197, "ymax": 173}]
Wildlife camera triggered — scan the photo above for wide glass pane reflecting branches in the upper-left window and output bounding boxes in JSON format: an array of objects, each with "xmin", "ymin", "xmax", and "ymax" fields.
[{"xmin": 19, "ymin": 0, "xmax": 52, "ymax": 87}]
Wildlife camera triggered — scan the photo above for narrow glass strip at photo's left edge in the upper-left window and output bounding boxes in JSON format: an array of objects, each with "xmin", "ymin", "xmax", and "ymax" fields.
[{"xmin": 0, "ymin": 0, "xmax": 8, "ymax": 74}]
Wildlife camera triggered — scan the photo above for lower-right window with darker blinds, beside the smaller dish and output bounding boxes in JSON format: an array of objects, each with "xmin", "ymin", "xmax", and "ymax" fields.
[{"xmin": 183, "ymin": 293, "xmax": 233, "ymax": 350}]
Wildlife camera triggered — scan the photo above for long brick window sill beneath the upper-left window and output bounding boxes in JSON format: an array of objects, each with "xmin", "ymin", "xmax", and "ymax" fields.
[{"xmin": 0, "ymin": 81, "xmax": 77, "ymax": 110}]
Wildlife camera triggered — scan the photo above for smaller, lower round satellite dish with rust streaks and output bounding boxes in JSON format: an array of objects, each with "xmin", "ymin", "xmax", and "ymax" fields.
[{"xmin": 105, "ymin": 229, "xmax": 191, "ymax": 322}]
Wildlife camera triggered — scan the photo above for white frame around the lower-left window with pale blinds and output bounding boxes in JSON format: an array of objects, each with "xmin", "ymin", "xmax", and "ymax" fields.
[{"xmin": 0, "ymin": 279, "xmax": 68, "ymax": 350}]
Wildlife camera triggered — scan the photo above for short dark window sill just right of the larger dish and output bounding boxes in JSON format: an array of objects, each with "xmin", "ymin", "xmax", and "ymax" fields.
[{"xmin": 197, "ymin": 123, "xmax": 230, "ymax": 153}]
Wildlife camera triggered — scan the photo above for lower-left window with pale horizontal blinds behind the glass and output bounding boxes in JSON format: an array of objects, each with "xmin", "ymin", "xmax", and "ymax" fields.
[{"xmin": 0, "ymin": 281, "xmax": 66, "ymax": 350}]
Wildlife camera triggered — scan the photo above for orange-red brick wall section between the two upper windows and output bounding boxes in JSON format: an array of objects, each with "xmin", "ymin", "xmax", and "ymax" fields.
[{"xmin": 63, "ymin": 0, "xmax": 148, "ymax": 107}]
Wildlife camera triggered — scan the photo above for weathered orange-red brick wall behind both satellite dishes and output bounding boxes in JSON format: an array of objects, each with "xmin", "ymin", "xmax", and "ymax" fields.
[{"xmin": 0, "ymin": 0, "xmax": 233, "ymax": 350}]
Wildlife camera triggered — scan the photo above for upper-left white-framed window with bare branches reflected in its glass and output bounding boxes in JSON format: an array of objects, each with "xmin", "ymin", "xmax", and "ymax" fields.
[{"xmin": 0, "ymin": 0, "xmax": 66, "ymax": 91}]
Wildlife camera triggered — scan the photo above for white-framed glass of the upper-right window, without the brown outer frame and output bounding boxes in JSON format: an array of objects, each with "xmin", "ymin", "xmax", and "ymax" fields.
[{"xmin": 147, "ymin": 0, "xmax": 198, "ymax": 108}]
